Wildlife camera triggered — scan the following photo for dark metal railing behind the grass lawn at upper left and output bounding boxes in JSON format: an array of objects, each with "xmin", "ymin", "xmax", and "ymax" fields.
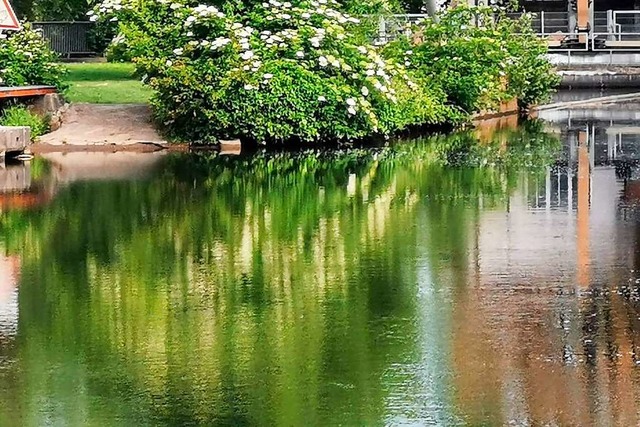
[{"xmin": 33, "ymin": 21, "xmax": 97, "ymax": 57}]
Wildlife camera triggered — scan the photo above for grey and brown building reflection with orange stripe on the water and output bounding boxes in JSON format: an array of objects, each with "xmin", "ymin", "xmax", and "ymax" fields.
[{"xmin": 453, "ymin": 106, "xmax": 640, "ymax": 426}]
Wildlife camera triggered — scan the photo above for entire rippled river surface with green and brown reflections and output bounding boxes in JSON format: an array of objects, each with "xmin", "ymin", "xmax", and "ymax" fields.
[{"xmin": 0, "ymin": 105, "xmax": 640, "ymax": 426}]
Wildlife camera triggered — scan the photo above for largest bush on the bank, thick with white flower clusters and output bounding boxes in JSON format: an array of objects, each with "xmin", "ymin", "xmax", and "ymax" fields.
[{"xmin": 92, "ymin": 0, "xmax": 450, "ymax": 142}]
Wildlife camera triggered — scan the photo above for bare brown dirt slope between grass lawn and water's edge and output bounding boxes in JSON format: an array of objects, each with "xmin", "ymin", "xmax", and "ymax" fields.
[{"xmin": 39, "ymin": 104, "xmax": 166, "ymax": 147}]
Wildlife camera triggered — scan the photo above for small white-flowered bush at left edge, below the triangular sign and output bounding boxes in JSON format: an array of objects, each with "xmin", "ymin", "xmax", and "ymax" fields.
[{"xmin": 0, "ymin": 24, "xmax": 64, "ymax": 89}]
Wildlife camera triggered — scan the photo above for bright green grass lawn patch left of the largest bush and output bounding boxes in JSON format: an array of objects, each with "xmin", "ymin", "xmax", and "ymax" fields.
[{"xmin": 65, "ymin": 63, "xmax": 151, "ymax": 104}]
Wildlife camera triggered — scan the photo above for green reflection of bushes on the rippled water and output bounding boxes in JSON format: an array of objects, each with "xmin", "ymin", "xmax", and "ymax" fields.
[{"xmin": 0, "ymin": 123, "xmax": 559, "ymax": 425}]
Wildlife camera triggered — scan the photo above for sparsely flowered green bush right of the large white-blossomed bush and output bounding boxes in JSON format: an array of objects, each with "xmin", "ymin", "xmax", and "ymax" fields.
[{"xmin": 385, "ymin": 6, "xmax": 558, "ymax": 114}]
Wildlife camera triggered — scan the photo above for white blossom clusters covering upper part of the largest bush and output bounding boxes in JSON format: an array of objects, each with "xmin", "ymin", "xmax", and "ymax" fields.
[{"xmin": 94, "ymin": 0, "xmax": 415, "ymax": 126}]
